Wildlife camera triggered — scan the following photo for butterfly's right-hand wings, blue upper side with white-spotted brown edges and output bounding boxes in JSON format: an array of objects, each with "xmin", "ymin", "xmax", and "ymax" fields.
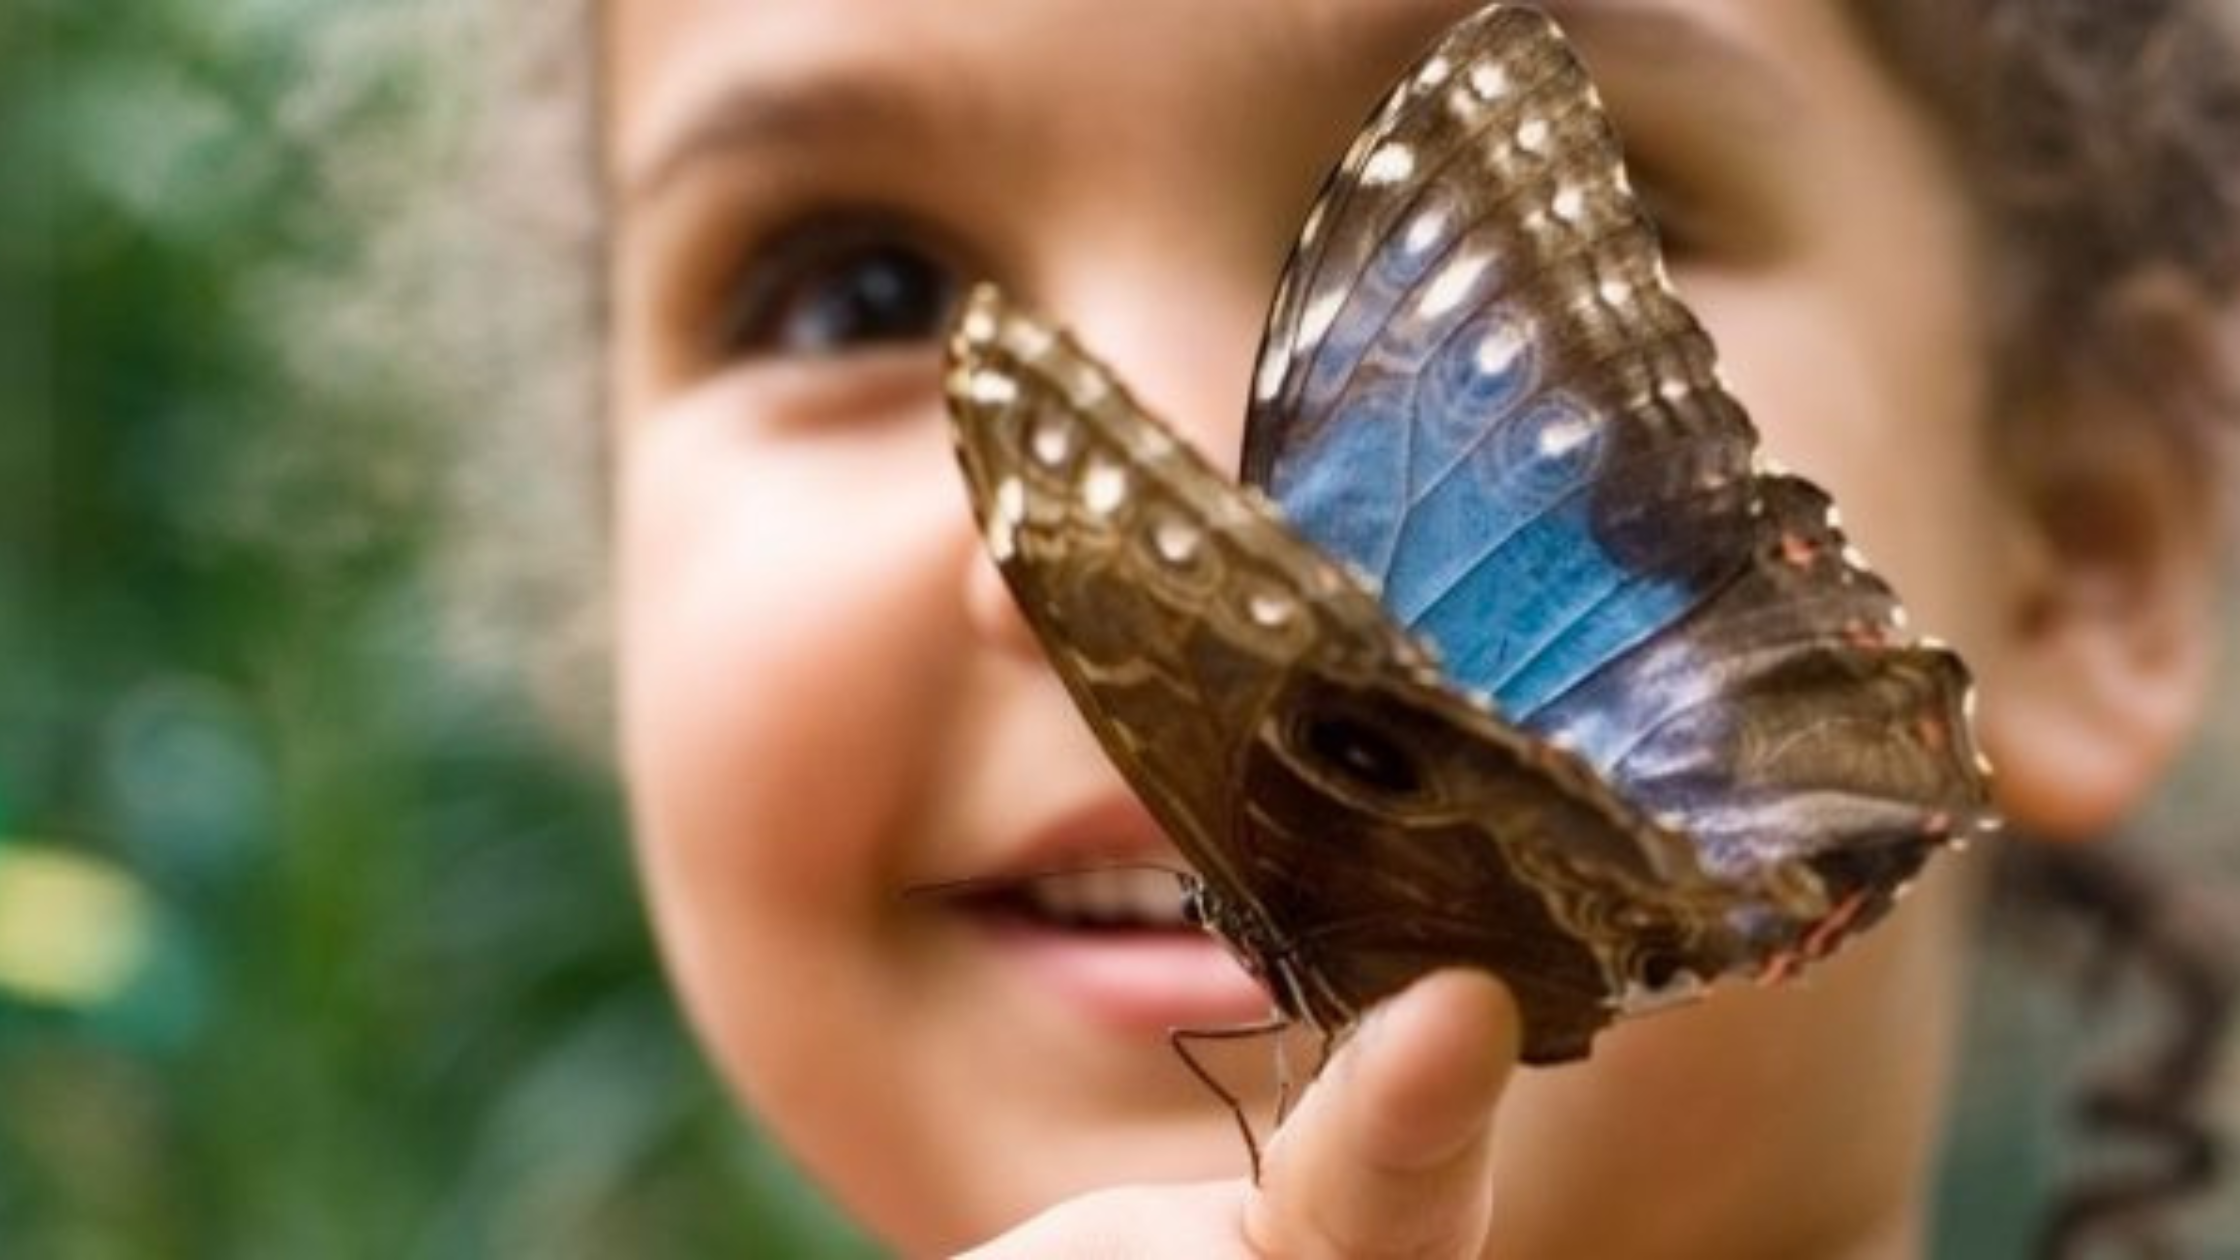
[{"xmin": 1243, "ymin": 7, "xmax": 1989, "ymax": 953}]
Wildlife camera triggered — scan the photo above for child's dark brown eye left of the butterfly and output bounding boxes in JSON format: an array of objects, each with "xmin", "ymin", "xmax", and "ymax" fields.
[{"xmin": 717, "ymin": 224, "xmax": 963, "ymax": 359}]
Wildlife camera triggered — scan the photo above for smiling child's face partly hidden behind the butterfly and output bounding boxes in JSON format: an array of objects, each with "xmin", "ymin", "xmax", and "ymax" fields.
[{"xmin": 609, "ymin": 0, "xmax": 2012, "ymax": 1253}]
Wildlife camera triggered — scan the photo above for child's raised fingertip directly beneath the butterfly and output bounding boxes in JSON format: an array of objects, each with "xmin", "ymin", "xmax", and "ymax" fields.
[{"xmin": 1245, "ymin": 971, "xmax": 1519, "ymax": 1260}]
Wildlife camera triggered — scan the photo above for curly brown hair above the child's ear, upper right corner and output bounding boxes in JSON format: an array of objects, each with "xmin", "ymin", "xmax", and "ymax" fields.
[{"xmin": 1850, "ymin": 0, "xmax": 2240, "ymax": 556}]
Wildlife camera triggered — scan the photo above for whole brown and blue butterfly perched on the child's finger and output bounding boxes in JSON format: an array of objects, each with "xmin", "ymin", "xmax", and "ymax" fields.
[{"xmin": 945, "ymin": 4, "xmax": 1996, "ymax": 1063}]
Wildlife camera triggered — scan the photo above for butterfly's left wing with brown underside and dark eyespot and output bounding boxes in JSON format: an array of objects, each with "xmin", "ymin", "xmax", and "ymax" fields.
[{"xmin": 948, "ymin": 289, "xmax": 1756, "ymax": 1060}]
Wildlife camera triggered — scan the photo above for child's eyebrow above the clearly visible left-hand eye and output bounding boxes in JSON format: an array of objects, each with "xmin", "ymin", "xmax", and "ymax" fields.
[{"xmin": 616, "ymin": 72, "xmax": 923, "ymax": 206}]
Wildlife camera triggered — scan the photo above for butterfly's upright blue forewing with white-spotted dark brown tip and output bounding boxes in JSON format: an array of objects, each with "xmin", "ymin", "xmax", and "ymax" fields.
[{"xmin": 1243, "ymin": 9, "xmax": 1754, "ymax": 715}]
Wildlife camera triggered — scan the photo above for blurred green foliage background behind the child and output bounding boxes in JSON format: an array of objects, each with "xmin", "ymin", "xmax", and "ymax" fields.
[{"xmin": 0, "ymin": 0, "xmax": 2240, "ymax": 1260}]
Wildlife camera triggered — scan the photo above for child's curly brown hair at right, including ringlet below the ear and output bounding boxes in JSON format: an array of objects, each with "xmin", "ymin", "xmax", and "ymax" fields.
[{"xmin": 1850, "ymin": 0, "xmax": 2240, "ymax": 1256}]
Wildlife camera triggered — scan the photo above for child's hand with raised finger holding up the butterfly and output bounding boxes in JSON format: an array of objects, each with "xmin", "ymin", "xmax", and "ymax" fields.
[{"xmin": 954, "ymin": 971, "xmax": 1519, "ymax": 1260}]
